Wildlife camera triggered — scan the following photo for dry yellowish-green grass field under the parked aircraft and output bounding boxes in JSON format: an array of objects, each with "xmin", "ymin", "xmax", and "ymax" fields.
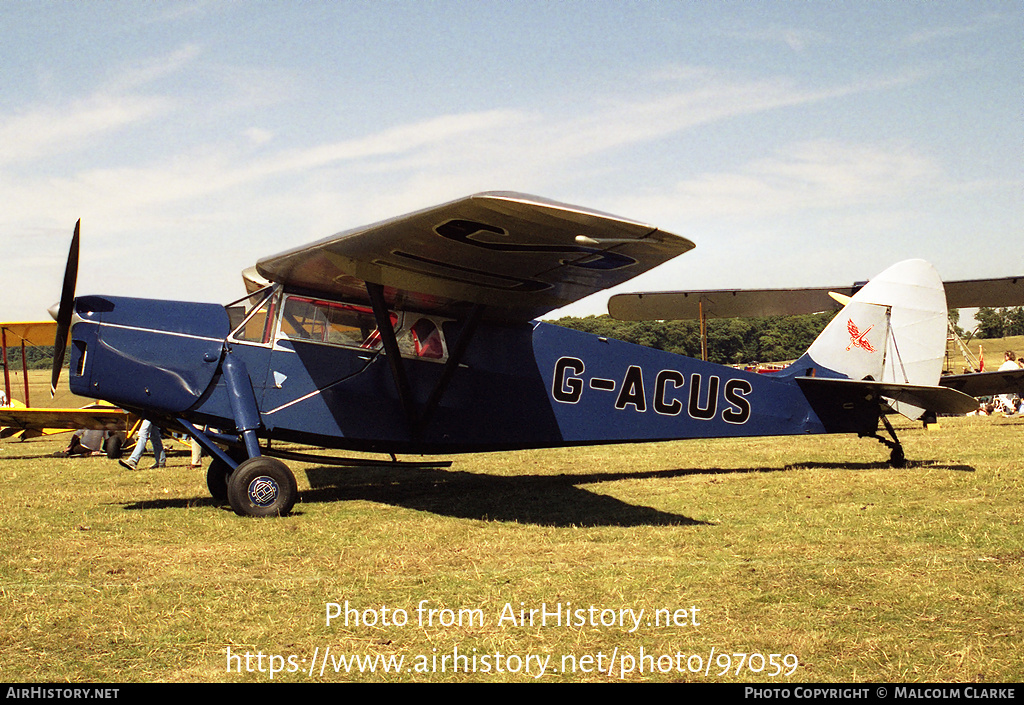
[{"xmin": 0, "ymin": 409, "xmax": 1024, "ymax": 682}]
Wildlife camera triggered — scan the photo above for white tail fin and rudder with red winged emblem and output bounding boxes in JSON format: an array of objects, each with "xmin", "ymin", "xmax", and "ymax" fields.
[{"xmin": 801, "ymin": 259, "xmax": 947, "ymax": 418}]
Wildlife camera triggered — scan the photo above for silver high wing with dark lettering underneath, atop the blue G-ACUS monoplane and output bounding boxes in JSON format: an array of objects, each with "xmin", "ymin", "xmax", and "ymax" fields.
[{"xmin": 256, "ymin": 192, "xmax": 693, "ymax": 321}]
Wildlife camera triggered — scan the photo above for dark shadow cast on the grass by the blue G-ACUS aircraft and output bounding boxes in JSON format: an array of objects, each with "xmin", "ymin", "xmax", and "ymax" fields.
[{"xmin": 117, "ymin": 463, "xmax": 974, "ymax": 527}]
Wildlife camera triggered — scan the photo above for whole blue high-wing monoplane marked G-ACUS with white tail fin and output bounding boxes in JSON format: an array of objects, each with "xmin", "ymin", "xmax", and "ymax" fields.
[{"xmin": 53, "ymin": 193, "xmax": 977, "ymax": 516}]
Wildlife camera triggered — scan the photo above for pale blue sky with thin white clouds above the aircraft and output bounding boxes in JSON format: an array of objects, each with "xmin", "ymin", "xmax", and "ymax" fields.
[{"xmin": 0, "ymin": 0, "xmax": 1024, "ymax": 320}]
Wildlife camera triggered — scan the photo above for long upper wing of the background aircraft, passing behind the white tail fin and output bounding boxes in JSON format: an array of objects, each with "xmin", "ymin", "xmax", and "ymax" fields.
[{"xmin": 608, "ymin": 277, "xmax": 1024, "ymax": 321}]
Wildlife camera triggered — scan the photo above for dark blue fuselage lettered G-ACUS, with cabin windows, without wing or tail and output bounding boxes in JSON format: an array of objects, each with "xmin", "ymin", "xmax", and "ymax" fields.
[{"xmin": 70, "ymin": 288, "xmax": 826, "ymax": 453}]
